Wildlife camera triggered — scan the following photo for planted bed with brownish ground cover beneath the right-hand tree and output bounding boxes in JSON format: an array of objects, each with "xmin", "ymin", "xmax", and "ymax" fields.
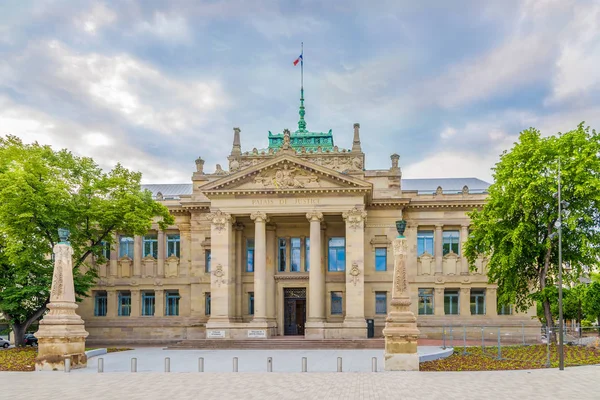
[{"xmin": 420, "ymin": 344, "xmax": 600, "ymax": 371}]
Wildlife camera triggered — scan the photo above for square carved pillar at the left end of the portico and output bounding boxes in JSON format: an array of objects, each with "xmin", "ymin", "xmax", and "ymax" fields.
[{"xmin": 206, "ymin": 210, "xmax": 235, "ymax": 332}]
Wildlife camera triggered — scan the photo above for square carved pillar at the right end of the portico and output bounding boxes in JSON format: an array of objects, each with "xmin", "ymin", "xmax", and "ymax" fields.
[{"xmin": 342, "ymin": 207, "xmax": 367, "ymax": 338}]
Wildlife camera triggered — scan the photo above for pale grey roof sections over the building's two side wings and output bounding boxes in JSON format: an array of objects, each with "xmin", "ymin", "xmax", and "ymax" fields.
[{"xmin": 142, "ymin": 178, "xmax": 490, "ymax": 200}]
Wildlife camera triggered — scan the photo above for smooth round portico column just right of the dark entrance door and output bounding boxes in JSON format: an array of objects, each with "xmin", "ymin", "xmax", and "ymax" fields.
[{"xmin": 305, "ymin": 211, "xmax": 325, "ymax": 339}]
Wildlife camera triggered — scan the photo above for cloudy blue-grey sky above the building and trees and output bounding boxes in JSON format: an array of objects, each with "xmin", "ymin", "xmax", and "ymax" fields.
[{"xmin": 0, "ymin": 0, "xmax": 600, "ymax": 183}]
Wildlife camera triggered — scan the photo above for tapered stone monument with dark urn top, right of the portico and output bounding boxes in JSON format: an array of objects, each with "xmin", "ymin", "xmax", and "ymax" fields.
[{"xmin": 383, "ymin": 220, "xmax": 419, "ymax": 371}]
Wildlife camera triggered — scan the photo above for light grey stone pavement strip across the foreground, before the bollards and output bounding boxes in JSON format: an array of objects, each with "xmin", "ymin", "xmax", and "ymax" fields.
[{"xmin": 0, "ymin": 366, "xmax": 600, "ymax": 400}]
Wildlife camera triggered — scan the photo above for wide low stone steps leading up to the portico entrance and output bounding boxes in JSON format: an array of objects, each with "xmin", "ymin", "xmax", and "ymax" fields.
[{"xmin": 168, "ymin": 337, "xmax": 385, "ymax": 350}]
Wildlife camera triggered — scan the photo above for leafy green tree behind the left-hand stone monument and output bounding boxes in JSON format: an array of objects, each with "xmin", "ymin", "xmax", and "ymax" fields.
[{"xmin": 0, "ymin": 136, "xmax": 173, "ymax": 345}]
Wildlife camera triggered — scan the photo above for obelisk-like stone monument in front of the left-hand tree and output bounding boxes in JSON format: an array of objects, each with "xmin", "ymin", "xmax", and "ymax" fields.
[{"xmin": 35, "ymin": 229, "xmax": 88, "ymax": 371}]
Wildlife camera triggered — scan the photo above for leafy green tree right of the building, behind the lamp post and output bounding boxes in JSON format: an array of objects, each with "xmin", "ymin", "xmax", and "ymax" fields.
[{"xmin": 465, "ymin": 124, "xmax": 600, "ymax": 336}]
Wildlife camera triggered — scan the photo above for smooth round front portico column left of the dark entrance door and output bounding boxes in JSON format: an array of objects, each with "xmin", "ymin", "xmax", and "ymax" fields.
[{"xmin": 250, "ymin": 211, "xmax": 267, "ymax": 323}]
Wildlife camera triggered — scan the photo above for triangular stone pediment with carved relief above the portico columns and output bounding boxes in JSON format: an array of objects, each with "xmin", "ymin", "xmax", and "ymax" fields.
[{"xmin": 201, "ymin": 154, "xmax": 372, "ymax": 194}]
